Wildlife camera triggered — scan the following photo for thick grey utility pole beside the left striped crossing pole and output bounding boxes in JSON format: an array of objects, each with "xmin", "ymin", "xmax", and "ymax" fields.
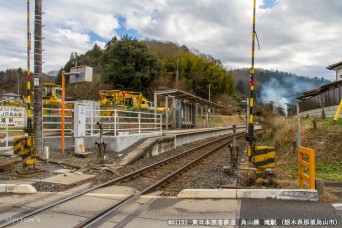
[{"xmin": 33, "ymin": 0, "xmax": 43, "ymax": 154}]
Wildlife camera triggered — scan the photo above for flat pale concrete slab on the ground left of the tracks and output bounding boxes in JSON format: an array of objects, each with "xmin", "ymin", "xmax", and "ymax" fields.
[{"xmin": 42, "ymin": 173, "xmax": 95, "ymax": 185}]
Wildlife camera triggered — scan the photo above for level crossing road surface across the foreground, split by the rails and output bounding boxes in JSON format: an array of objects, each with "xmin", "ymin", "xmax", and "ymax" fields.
[{"xmin": 0, "ymin": 186, "xmax": 342, "ymax": 228}]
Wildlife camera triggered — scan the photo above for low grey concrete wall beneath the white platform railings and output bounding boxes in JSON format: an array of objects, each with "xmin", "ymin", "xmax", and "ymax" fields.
[{"xmin": 43, "ymin": 133, "xmax": 162, "ymax": 152}]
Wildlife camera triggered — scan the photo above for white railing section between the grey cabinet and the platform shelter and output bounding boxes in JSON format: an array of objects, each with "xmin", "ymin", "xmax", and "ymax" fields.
[{"xmin": 86, "ymin": 109, "xmax": 163, "ymax": 136}]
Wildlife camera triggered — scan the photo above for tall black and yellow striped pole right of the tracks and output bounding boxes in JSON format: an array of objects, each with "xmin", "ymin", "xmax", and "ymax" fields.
[{"xmin": 247, "ymin": 0, "xmax": 256, "ymax": 161}]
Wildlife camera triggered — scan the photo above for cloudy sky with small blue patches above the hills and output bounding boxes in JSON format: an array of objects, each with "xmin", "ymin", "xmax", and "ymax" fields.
[{"xmin": 0, "ymin": 0, "xmax": 342, "ymax": 80}]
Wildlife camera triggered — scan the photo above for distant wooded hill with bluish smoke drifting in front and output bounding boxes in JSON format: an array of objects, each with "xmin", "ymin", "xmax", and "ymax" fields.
[{"xmin": 232, "ymin": 69, "xmax": 330, "ymax": 114}]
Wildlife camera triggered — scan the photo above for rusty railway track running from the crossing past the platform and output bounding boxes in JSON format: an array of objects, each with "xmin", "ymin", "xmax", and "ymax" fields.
[{"xmin": 0, "ymin": 133, "xmax": 245, "ymax": 227}]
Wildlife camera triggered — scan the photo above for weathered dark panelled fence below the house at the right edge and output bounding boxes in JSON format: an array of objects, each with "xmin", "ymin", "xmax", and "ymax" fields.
[{"xmin": 299, "ymin": 87, "xmax": 342, "ymax": 112}]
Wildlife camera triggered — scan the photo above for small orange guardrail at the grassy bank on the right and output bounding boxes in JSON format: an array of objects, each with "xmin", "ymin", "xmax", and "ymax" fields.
[{"xmin": 298, "ymin": 146, "xmax": 316, "ymax": 189}]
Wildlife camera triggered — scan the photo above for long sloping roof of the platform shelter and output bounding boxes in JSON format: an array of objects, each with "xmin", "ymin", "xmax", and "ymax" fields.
[{"xmin": 154, "ymin": 89, "xmax": 224, "ymax": 109}]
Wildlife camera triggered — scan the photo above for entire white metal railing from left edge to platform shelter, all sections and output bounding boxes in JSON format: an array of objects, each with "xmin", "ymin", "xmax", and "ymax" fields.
[{"xmin": 0, "ymin": 108, "xmax": 163, "ymax": 149}]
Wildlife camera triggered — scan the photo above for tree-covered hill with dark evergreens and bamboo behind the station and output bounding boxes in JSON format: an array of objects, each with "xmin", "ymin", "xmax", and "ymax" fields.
[{"xmin": 56, "ymin": 36, "xmax": 235, "ymax": 102}]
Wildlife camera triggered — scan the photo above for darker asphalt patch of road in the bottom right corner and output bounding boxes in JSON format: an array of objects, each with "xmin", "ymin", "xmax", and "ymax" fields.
[{"xmin": 239, "ymin": 199, "xmax": 342, "ymax": 227}]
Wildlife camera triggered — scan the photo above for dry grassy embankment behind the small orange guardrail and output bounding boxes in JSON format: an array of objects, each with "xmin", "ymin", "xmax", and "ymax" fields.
[{"xmin": 257, "ymin": 115, "xmax": 342, "ymax": 200}]
